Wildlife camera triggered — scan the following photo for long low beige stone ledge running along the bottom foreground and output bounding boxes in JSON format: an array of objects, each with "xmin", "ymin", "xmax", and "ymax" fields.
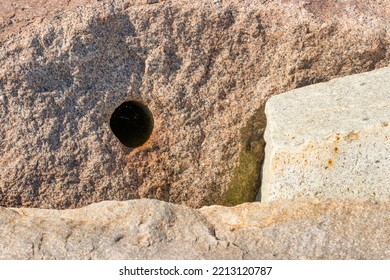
[{"xmin": 0, "ymin": 199, "xmax": 390, "ymax": 259}]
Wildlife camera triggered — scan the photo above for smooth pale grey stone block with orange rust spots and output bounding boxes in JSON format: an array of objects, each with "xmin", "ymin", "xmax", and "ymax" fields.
[{"xmin": 261, "ymin": 67, "xmax": 390, "ymax": 201}]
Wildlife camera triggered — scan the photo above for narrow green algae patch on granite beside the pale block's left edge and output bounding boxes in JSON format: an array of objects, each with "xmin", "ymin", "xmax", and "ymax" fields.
[{"xmin": 221, "ymin": 105, "xmax": 267, "ymax": 206}]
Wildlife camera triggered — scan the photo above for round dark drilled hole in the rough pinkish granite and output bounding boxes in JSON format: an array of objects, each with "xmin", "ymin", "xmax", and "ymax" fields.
[{"xmin": 110, "ymin": 101, "xmax": 153, "ymax": 148}]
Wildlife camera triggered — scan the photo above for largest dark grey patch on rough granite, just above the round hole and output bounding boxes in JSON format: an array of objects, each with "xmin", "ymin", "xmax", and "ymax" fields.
[{"xmin": 70, "ymin": 14, "xmax": 145, "ymax": 90}]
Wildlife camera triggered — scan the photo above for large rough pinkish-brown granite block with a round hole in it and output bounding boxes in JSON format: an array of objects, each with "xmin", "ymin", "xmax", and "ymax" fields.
[{"xmin": 0, "ymin": 0, "xmax": 390, "ymax": 208}]
